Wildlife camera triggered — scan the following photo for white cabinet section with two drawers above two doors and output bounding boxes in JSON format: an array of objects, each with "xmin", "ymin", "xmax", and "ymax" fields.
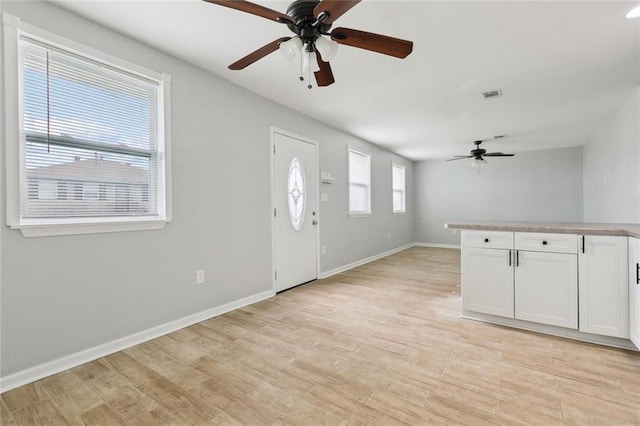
[{"xmin": 461, "ymin": 231, "xmax": 578, "ymax": 329}]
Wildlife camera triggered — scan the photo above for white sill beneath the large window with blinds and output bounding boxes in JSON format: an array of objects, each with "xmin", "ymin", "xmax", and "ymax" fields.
[{"xmin": 10, "ymin": 218, "xmax": 169, "ymax": 238}]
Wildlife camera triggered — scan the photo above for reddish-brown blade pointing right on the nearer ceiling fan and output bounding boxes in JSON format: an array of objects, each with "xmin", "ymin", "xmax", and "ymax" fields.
[{"xmin": 331, "ymin": 28, "xmax": 413, "ymax": 58}]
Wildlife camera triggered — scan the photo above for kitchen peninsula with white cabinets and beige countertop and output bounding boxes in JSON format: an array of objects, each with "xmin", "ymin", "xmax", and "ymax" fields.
[{"xmin": 445, "ymin": 222, "xmax": 640, "ymax": 350}]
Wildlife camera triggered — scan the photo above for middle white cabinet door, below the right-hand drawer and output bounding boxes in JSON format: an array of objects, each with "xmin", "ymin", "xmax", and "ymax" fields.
[{"xmin": 515, "ymin": 251, "xmax": 578, "ymax": 329}]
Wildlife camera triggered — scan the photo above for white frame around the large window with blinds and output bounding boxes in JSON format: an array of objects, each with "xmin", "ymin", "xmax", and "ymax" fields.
[{"xmin": 2, "ymin": 12, "xmax": 173, "ymax": 237}]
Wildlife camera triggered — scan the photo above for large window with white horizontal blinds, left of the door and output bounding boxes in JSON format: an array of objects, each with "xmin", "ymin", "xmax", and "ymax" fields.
[{"xmin": 3, "ymin": 16, "xmax": 168, "ymax": 236}]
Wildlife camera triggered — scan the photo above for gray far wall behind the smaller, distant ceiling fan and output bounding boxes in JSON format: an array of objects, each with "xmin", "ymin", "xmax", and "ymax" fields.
[{"xmin": 415, "ymin": 147, "xmax": 582, "ymax": 245}]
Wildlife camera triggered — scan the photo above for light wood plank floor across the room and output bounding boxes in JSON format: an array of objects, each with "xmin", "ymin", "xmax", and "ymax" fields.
[{"xmin": 1, "ymin": 248, "xmax": 640, "ymax": 425}]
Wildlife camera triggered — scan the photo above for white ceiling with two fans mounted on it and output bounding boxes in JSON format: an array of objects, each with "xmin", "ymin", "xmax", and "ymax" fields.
[{"xmin": 47, "ymin": 0, "xmax": 640, "ymax": 160}]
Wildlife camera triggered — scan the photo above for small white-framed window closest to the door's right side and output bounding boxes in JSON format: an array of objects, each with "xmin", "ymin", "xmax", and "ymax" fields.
[{"xmin": 349, "ymin": 148, "xmax": 371, "ymax": 215}]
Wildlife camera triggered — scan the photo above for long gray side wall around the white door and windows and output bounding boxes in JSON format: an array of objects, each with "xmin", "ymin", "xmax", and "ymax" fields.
[{"xmin": 0, "ymin": 2, "xmax": 414, "ymax": 377}]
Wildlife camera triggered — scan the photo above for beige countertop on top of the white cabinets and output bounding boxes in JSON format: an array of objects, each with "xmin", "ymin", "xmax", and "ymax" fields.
[{"xmin": 444, "ymin": 221, "xmax": 640, "ymax": 238}]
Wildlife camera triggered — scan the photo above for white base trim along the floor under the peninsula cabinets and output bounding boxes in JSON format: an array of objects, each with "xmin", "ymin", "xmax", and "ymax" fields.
[{"xmin": 461, "ymin": 310, "xmax": 638, "ymax": 352}]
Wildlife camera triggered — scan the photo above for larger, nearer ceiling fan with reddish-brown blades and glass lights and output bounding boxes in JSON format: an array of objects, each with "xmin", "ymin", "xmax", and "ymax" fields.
[{"xmin": 204, "ymin": 0, "xmax": 413, "ymax": 88}]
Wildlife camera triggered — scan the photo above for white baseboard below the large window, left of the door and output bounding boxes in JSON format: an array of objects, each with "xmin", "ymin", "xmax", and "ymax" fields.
[{"xmin": 0, "ymin": 290, "xmax": 275, "ymax": 393}]
